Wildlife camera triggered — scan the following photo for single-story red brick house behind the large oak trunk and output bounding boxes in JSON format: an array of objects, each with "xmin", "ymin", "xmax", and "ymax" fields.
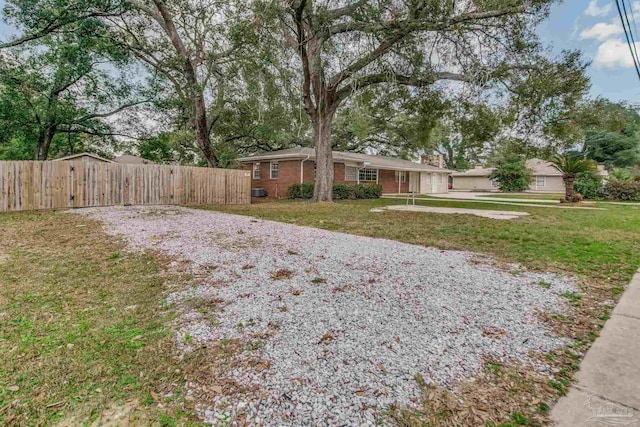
[{"xmin": 238, "ymin": 148, "xmax": 453, "ymax": 198}]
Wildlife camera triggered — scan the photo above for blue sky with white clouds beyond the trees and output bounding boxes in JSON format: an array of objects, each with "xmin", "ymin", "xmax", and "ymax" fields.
[{"xmin": 0, "ymin": 0, "xmax": 640, "ymax": 103}]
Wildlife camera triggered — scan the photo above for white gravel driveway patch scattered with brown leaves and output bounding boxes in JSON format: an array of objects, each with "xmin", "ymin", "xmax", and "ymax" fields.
[{"xmin": 76, "ymin": 205, "xmax": 576, "ymax": 426}]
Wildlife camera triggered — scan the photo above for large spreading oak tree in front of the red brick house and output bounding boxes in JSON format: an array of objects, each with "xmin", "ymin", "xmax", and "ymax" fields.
[{"xmin": 272, "ymin": 0, "xmax": 582, "ymax": 201}]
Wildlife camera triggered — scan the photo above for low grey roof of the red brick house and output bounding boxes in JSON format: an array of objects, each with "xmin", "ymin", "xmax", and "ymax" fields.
[{"xmin": 238, "ymin": 148, "xmax": 453, "ymax": 173}]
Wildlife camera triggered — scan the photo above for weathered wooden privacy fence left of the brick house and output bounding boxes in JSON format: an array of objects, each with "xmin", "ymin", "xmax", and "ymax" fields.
[{"xmin": 0, "ymin": 161, "xmax": 251, "ymax": 211}]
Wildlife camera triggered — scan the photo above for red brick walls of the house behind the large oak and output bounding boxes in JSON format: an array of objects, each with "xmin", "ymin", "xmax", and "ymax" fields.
[{"xmin": 241, "ymin": 160, "xmax": 402, "ymax": 199}]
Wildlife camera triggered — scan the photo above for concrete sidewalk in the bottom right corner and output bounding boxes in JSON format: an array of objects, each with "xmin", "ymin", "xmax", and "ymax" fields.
[{"xmin": 551, "ymin": 272, "xmax": 640, "ymax": 427}]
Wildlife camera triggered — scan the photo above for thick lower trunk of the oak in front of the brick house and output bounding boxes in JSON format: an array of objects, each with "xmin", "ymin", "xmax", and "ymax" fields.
[{"xmin": 313, "ymin": 112, "xmax": 333, "ymax": 202}]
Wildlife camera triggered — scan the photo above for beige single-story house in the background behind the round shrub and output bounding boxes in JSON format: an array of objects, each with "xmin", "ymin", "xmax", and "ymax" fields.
[{"xmin": 452, "ymin": 159, "xmax": 609, "ymax": 193}]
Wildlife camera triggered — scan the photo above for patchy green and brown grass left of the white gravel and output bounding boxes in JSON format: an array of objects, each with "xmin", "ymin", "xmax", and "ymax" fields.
[{"xmin": 0, "ymin": 212, "xmax": 208, "ymax": 426}]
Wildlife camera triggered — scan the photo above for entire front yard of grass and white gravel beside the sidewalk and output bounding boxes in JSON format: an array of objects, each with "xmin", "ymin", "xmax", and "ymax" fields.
[{"xmin": 0, "ymin": 200, "xmax": 640, "ymax": 426}]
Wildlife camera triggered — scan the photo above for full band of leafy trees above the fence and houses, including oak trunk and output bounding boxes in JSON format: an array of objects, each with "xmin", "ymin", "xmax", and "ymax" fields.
[{"xmin": 0, "ymin": 0, "xmax": 640, "ymax": 201}]
